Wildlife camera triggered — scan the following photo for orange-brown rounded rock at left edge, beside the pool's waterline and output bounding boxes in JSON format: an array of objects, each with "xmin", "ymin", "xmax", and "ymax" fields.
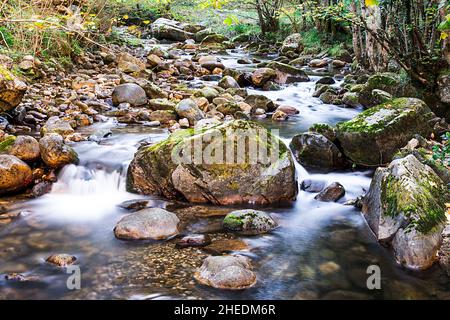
[{"xmin": 0, "ymin": 155, "xmax": 33, "ymax": 194}]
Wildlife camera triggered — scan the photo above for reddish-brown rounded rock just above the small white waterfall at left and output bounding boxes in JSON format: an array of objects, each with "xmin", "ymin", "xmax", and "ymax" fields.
[{"xmin": 39, "ymin": 133, "xmax": 78, "ymax": 169}]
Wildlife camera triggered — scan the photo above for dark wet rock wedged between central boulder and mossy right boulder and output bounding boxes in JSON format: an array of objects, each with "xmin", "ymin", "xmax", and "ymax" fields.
[{"xmin": 289, "ymin": 132, "xmax": 347, "ymax": 169}]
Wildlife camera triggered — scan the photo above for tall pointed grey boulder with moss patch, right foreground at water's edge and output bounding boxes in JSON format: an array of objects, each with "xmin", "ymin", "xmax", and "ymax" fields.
[{"xmin": 363, "ymin": 155, "xmax": 449, "ymax": 270}]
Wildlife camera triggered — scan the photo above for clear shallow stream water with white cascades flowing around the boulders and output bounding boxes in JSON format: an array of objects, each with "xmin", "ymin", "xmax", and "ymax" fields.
[{"xmin": 0, "ymin": 50, "xmax": 450, "ymax": 299}]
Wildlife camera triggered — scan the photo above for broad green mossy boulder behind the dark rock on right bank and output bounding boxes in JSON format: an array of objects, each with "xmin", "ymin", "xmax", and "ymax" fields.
[{"xmin": 336, "ymin": 98, "xmax": 435, "ymax": 166}]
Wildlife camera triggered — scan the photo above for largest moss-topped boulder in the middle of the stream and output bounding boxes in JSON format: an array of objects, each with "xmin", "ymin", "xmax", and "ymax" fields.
[{"xmin": 127, "ymin": 120, "xmax": 297, "ymax": 205}]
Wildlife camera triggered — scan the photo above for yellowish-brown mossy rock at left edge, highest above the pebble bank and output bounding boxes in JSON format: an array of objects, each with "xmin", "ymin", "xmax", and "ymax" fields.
[{"xmin": 0, "ymin": 65, "xmax": 27, "ymax": 112}]
